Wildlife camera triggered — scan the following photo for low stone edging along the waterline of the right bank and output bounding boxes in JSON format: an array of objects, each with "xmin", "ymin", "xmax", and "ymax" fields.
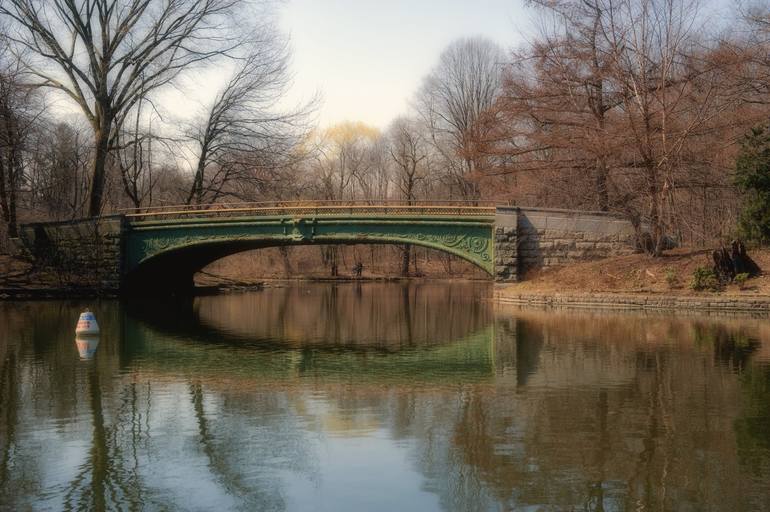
[{"xmin": 495, "ymin": 289, "xmax": 770, "ymax": 315}]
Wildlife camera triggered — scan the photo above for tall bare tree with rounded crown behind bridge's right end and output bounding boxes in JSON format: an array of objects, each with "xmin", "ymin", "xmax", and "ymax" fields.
[{"xmin": 416, "ymin": 38, "xmax": 505, "ymax": 199}]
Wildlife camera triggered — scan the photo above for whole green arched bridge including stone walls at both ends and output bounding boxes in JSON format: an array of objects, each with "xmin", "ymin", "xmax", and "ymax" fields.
[{"xmin": 18, "ymin": 202, "xmax": 630, "ymax": 293}]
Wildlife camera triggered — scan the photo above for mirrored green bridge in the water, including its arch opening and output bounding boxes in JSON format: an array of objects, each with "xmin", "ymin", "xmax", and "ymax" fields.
[{"xmin": 125, "ymin": 283, "xmax": 495, "ymax": 381}]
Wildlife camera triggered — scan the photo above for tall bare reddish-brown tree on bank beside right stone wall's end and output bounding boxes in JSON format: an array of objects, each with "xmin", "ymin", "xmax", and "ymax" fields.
[{"xmin": 610, "ymin": 0, "xmax": 718, "ymax": 255}]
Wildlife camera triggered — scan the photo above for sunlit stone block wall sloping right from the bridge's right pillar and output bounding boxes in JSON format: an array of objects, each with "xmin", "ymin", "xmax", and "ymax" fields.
[{"xmin": 518, "ymin": 208, "xmax": 636, "ymax": 274}]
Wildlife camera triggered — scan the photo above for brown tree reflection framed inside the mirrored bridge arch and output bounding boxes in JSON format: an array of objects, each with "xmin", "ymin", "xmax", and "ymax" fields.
[{"xmin": 190, "ymin": 283, "xmax": 491, "ymax": 349}]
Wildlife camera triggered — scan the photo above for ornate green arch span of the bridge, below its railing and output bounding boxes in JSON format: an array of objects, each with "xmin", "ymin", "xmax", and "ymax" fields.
[{"xmin": 122, "ymin": 211, "xmax": 494, "ymax": 293}]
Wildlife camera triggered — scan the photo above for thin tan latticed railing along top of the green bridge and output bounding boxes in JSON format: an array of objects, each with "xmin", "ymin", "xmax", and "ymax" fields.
[{"xmin": 121, "ymin": 201, "xmax": 495, "ymax": 220}]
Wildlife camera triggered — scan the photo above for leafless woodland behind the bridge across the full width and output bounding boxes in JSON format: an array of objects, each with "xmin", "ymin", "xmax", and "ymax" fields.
[{"xmin": 0, "ymin": 0, "xmax": 770, "ymax": 273}]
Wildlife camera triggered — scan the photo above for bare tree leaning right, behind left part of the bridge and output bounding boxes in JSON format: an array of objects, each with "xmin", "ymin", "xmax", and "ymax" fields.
[{"xmin": 187, "ymin": 37, "xmax": 317, "ymax": 204}]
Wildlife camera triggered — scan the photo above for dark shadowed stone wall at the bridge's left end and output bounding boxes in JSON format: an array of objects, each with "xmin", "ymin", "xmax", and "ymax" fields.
[{"xmin": 19, "ymin": 216, "xmax": 125, "ymax": 293}]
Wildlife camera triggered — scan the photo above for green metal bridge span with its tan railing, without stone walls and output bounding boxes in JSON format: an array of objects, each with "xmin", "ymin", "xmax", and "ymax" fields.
[{"xmin": 118, "ymin": 203, "xmax": 495, "ymax": 292}]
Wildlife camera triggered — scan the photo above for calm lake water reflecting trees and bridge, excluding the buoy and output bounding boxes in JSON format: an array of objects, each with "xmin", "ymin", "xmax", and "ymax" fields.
[{"xmin": 0, "ymin": 283, "xmax": 770, "ymax": 512}]
